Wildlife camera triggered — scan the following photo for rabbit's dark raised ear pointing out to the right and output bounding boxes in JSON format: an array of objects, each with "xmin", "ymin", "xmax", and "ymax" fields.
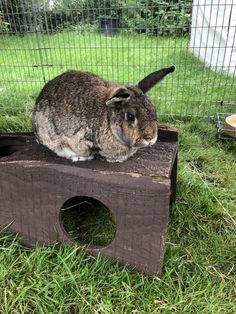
[{"xmin": 138, "ymin": 65, "xmax": 175, "ymax": 93}]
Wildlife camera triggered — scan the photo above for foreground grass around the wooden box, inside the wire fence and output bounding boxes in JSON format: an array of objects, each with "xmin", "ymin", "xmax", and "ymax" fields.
[{"xmin": 0, "ymin": 120, "xmax": 236, "ymax": 314}]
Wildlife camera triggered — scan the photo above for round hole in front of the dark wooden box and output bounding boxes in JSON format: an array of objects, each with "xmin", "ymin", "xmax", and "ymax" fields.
[{"xmin": 60, "ymin": 196, "xmax": 116, "ymax": 246}]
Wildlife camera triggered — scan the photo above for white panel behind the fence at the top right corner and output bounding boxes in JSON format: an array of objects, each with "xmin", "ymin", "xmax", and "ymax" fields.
[{"xmin": 190, "ymin": 0, "xmax": 236, "ymax": 74}]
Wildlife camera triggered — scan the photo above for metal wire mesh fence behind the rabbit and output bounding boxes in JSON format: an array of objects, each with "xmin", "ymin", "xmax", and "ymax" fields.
[{"xmin": 0, "ymin": 0, "xmax": 236, "ymax": 117}]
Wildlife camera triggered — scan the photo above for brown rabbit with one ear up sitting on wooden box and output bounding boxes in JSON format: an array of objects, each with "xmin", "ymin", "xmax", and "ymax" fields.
[{"xmin": 32, "ymin": 66, "xmax": 175, "ymax": 162}]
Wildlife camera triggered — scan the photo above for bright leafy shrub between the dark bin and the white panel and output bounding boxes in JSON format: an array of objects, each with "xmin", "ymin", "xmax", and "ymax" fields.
[{"xmin": 122, "ymin": 0, "xmax": 192, "ymax": 36}]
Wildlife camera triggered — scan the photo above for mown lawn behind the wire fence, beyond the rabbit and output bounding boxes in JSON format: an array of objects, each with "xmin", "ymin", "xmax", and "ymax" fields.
[{"xmin": 0, "ymin": 31, "xmax": 236, "ymax": 116}]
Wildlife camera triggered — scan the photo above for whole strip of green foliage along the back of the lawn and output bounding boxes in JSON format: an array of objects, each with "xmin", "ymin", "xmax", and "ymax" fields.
[{"xmin": 0, "ymin": 0, "xmax": 192, "ymax": 36}]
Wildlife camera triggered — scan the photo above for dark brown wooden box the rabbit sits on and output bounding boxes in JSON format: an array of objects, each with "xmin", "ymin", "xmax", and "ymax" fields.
[{"xmin": 0, "ymin": 126, "xmax": 178, "ymax": 275}]
